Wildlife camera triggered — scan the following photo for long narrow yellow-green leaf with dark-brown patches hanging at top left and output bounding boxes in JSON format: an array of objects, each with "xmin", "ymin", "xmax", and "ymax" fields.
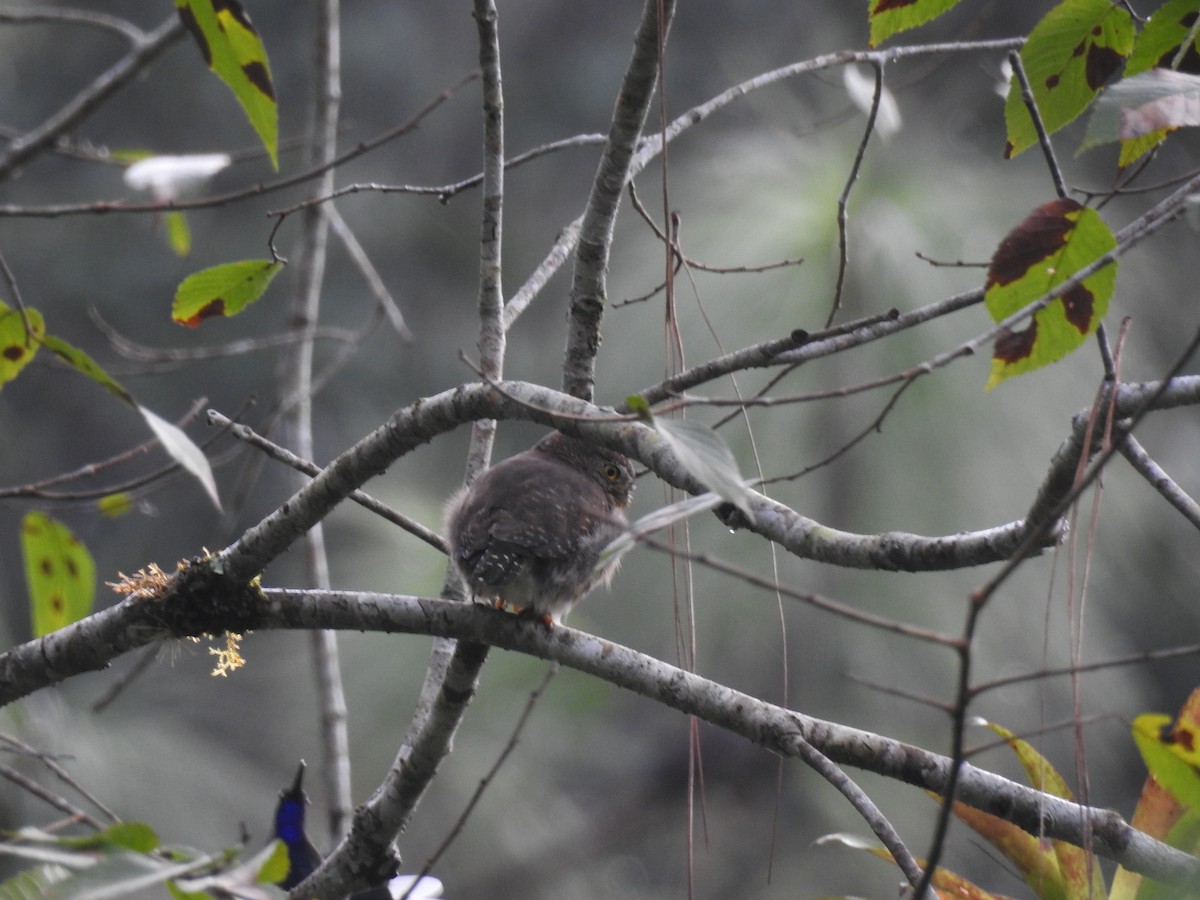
[{"xmin": 175, "ymin": 0, "xmax": 280, "ymax": 169}]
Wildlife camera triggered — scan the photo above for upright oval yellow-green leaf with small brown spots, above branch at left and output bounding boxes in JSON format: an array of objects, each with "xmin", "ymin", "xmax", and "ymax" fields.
[{"xmin": 20, "ymin": 512, "xmax": 96, "ymax": 637}]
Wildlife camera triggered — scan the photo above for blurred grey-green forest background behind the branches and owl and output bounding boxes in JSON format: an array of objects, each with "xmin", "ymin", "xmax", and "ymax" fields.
[{"xmin": 0, "ymin": 0, "xmax": 1200, "ymax": 900}]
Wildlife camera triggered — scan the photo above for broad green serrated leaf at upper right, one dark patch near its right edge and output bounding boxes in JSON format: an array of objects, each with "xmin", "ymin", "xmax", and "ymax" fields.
[{"xmin": 1004, "ymin": 0, "xmax": 1134, "ymax": 157}]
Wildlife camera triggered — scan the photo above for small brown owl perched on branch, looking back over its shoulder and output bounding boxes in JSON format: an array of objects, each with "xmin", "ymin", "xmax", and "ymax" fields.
[{"xmin": 445, "ymin": 431, "xmax": 634, "ymax": 625}]
